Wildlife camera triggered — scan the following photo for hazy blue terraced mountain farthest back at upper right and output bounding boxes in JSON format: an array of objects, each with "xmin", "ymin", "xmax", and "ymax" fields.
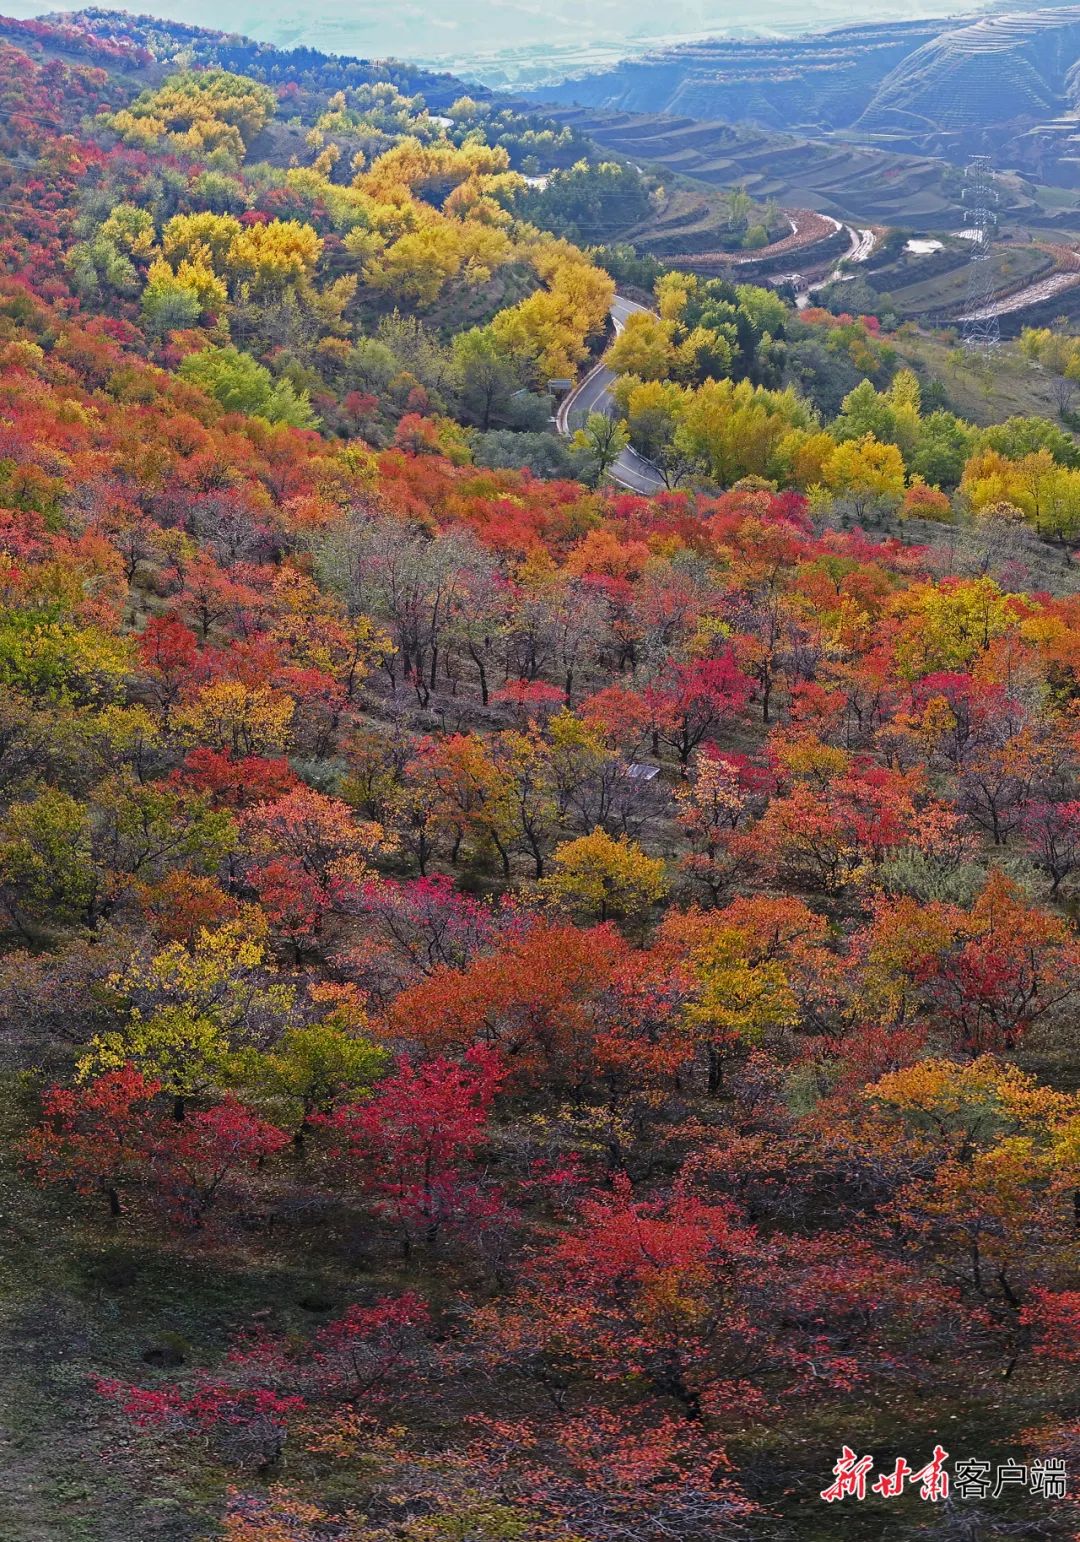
[{"xmin": 545, "ymin": 5, "xmax": 1080, "ymax": 187}]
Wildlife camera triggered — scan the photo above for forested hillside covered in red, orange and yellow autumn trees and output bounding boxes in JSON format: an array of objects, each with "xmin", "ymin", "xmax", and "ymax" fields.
[{"xmin": 0, "ymin": 12, "xmax": 1080, "ymax": 1542}]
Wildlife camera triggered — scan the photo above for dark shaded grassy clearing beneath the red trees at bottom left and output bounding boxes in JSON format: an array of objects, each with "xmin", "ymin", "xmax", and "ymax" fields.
[{"xmin": 0, "ymin": 1081, "xmax": 417, "ymax": 1542}]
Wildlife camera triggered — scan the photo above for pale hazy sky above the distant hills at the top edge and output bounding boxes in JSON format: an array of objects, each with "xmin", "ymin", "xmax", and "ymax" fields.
[{"xmin": 10, "ymin": 0, "xmax": 993, "ymax": 83}]
